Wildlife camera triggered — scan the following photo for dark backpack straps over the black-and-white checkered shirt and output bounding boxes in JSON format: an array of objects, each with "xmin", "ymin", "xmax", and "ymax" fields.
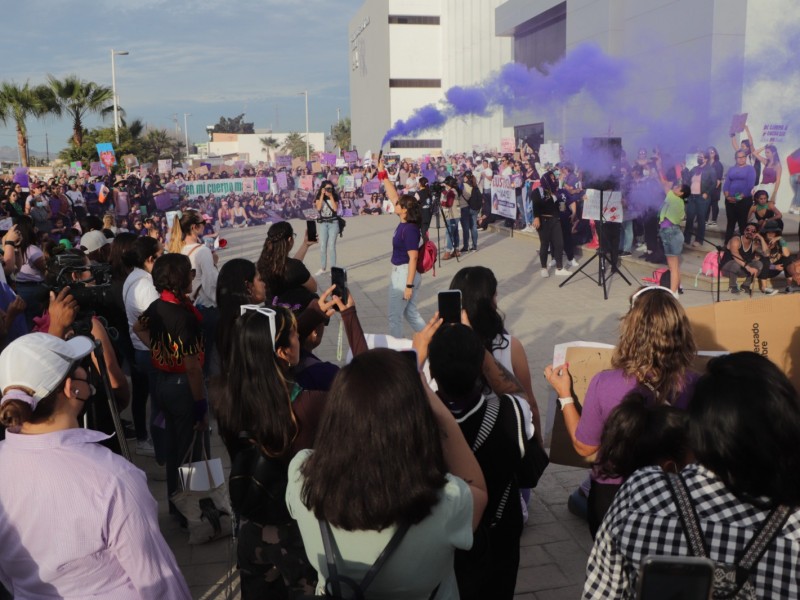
[{"xmin": 664, "ymin": 473, "xmax": 792, "ymax": 600}]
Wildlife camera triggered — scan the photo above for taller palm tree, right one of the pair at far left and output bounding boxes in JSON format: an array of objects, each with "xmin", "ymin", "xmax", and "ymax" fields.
[{"xmin": 47, "ymin": 75, "xmax": 114, "ymax": 147}]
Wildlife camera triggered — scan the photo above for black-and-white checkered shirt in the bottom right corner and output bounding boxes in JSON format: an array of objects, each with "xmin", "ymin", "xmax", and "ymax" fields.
[{"xmin": 583, "ymin": 465, "xmax": 800, "ymax": 599}]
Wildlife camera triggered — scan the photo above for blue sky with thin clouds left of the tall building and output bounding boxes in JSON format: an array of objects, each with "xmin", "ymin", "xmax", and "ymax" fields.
[{"xmin": 0, "ymin": 0, "xmax": 362, "ymax": 156}]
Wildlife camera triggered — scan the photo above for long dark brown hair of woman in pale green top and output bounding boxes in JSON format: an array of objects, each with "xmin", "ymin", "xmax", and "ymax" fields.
[{"xmin": 301, "ymin": 348, "xmax": 447, "ymax": 531}]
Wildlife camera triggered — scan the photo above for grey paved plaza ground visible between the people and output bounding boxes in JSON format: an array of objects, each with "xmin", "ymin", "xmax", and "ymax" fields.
[{"xmin": 126, "ymin": 215, "xmax": 756, "ymax": 600}]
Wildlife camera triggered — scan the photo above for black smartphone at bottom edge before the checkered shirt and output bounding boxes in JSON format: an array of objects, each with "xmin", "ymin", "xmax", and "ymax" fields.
[{"xmin": 636, "ymin": 556, "xmax": 714, "ymax": 600}]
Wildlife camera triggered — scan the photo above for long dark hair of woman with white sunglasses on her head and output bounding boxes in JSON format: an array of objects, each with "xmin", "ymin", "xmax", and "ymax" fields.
[{"xmin": 214, "ymin": 309, "xmax": 299, "ymax": 456}]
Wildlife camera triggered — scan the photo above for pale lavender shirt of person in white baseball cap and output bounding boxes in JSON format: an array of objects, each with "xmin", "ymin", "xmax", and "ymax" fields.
[{"xmin": 0, "ymin": 429, "xmax": 191, "ymax": 600}]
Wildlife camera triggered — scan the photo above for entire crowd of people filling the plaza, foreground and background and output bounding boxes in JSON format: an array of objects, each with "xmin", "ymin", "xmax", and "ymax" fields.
[{"xmin": 0, "ymin": 140, "xmax": 800, "ymax": 599}]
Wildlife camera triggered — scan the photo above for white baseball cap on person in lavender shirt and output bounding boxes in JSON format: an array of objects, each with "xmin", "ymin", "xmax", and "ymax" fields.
[{"xmin": 0, "ymin": 333, "xmax": 94, "ymax": 409}]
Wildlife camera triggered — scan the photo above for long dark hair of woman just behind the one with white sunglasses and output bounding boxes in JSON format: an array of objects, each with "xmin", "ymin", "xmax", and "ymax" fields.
[{"xmin": 217, "ymin": 258, "xmax": 256, "ymax": 376}]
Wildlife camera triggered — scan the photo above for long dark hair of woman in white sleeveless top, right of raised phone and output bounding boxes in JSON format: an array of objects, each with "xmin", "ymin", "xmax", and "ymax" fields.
[{"xmin": 450, "ymin": 266, "xmax": 509, "ymax": 352}]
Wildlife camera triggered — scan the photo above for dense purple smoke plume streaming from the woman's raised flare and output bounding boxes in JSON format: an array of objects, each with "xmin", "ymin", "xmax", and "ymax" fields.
[{"xmin": 381, "ymin": 43, "xmax": 626, "ymax": 146}]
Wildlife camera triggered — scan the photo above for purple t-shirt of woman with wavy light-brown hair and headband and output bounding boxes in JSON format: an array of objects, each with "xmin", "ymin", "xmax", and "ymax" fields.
[{"xmin": 575, "ymin": 369, "xmax": 699, "ymax": 483}]
